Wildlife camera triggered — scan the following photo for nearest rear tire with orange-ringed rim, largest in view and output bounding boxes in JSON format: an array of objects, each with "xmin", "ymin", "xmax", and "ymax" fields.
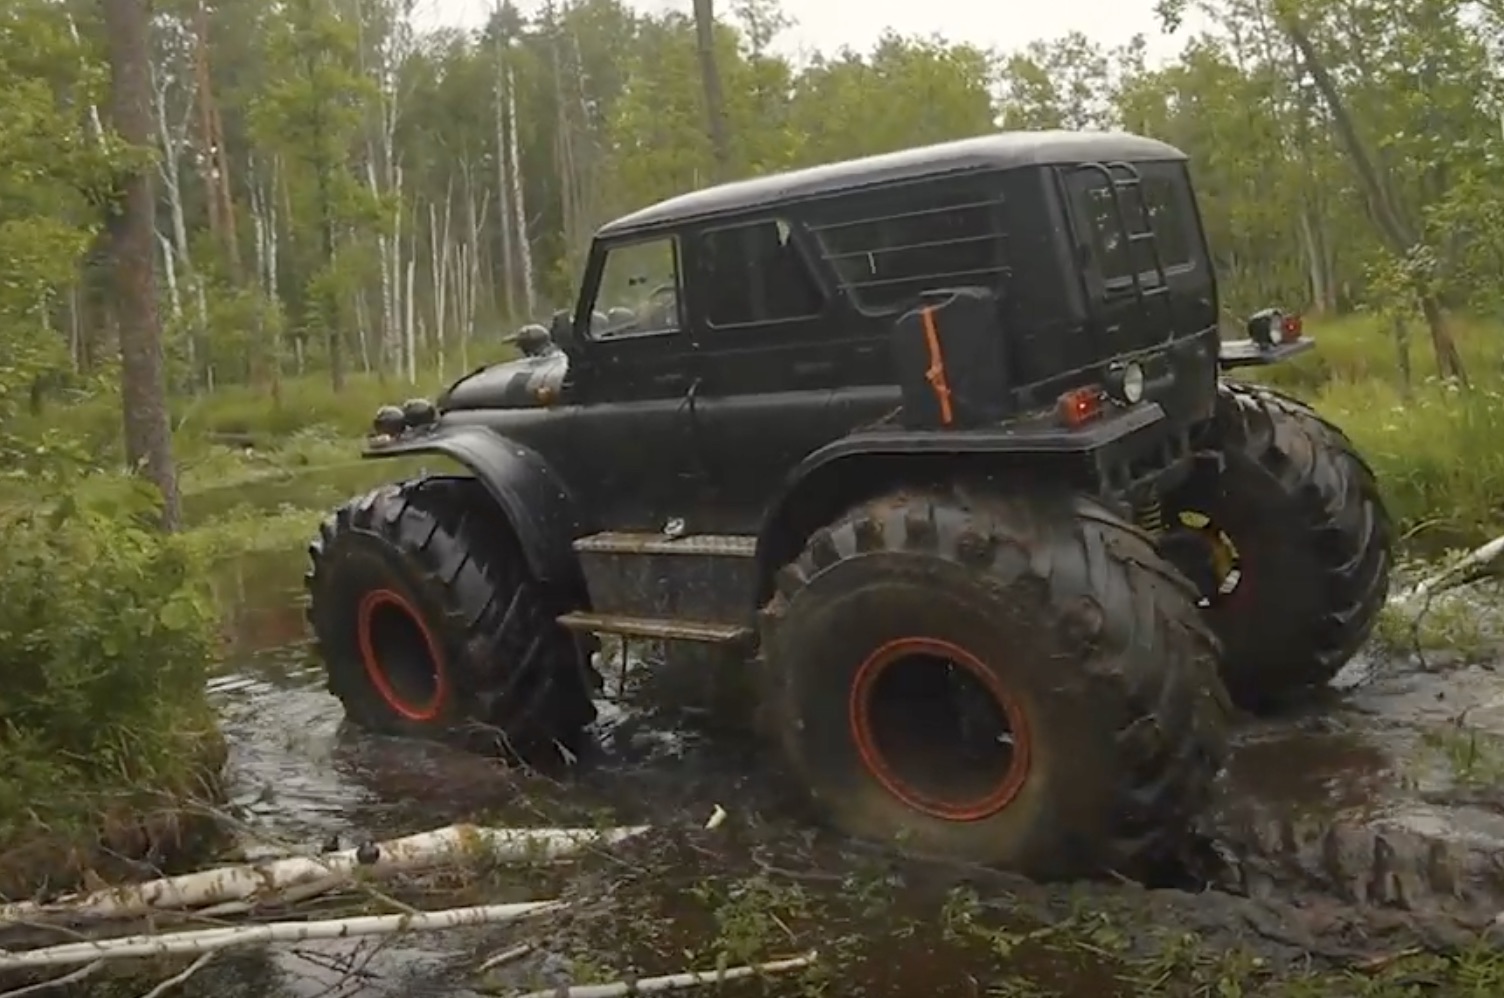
[{"xmin": 761, "ymin": 490, "xmax": 1230, "ymax": 879}]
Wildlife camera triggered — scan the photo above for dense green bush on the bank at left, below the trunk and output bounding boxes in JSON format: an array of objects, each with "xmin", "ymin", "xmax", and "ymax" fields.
[{"xmin": 0, "ymin": 491, "xmax": 217, "ymax": 848}]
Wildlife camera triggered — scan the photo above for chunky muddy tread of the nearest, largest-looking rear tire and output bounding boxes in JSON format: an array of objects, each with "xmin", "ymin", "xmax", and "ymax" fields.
[{"xmin": 761, "ymin": 490, "xmax": 1232, "ymax": 873}]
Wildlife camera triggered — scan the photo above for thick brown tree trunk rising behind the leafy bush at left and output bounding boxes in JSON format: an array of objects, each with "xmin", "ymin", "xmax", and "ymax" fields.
[{"xmin": 102, "ymin": 0, "xmax": 180, "ymax": 531}]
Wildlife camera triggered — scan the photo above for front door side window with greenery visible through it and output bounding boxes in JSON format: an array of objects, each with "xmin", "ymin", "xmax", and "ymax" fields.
[{"xmin": 590, "ymin": 237, "xmax": 680, "ymax": 340}]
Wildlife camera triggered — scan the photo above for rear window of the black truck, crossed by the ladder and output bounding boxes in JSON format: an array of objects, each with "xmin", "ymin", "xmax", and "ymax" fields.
[{"xmin": 1075, "ymin": 171, "xmax": 1196, "ymax": 286}]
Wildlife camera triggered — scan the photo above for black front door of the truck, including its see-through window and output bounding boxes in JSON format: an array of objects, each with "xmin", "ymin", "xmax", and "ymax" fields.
[{"xmin": 572, "ymin": 236, "xmax": 704, "ymax": 531}]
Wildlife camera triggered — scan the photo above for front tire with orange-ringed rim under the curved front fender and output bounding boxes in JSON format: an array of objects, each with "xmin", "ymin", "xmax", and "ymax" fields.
[{"xmin": 305, "ymin": 476, "xmax": 596, "ymax": 762}]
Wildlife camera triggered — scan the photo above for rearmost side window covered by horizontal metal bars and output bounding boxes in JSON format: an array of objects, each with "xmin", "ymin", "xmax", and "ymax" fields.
[{"xmin": 815, "ymin": 176, "xmax": 1008, "ymax": 313}]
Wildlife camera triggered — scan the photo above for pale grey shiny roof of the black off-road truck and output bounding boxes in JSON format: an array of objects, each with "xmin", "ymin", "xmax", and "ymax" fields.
[{"xmin": 597, "ymin": 131, "xmax": 1187, "ymax": 236}]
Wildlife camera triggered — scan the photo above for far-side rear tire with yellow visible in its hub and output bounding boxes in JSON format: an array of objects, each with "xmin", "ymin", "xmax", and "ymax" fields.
[{"xmin": 1160, "ymin": 383, "xmax": 1394, "ymax": 711}]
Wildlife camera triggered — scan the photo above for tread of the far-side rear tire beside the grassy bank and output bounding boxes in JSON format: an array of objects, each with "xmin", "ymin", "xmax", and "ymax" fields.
[{"xmin": 1215, "ymin": 382, "xmax": 1394, "ymax": 696}]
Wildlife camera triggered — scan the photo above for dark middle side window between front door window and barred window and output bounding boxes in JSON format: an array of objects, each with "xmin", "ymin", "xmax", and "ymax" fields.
[{"xmin": 696, "ymin": 218, "xmax": 824, "ymax": 328}]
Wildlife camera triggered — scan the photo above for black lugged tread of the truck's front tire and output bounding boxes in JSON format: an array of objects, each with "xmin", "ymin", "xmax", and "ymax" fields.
[{"xmin": 304, "ymin": 476, "xmax": 596, "ymax": 755}]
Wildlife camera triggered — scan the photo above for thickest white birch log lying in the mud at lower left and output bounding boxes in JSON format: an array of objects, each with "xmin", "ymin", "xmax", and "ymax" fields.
[{"xmin": 0, "ymin": 825, "xmax": 647, "ymax": 927}]
